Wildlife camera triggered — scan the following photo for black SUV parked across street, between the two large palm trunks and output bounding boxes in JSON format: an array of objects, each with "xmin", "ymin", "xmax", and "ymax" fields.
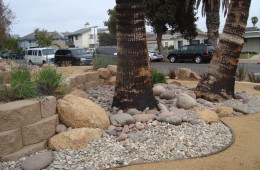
[{"xmin": 167, "ymin": 44, "xmax": 215, "ymax": 63}]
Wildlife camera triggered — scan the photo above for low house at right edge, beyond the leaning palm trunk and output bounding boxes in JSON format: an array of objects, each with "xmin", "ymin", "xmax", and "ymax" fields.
[{"xmin": 242, "ymin": 27, "xmax": 260, "ymax": 53}]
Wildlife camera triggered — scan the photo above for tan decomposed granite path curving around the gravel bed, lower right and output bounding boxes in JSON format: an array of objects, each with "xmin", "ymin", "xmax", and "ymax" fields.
[{"xmin": 113, "ymin": 114, "xmax": 260, "ymax": 170}]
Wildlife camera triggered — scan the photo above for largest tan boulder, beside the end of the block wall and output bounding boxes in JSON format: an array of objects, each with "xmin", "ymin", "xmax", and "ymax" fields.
[{"xmin": 57, "ymin": 95, "xmax": 110, "ymax": 129}]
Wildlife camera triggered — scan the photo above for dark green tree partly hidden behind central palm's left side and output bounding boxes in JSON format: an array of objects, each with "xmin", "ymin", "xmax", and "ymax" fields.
[{"xmin": 101, "ymin": 7, "xmax": 116, "ymax": 46}]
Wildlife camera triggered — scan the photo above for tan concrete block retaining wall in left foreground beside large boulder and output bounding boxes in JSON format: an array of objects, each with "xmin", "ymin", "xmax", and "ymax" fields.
[{"xmin": 0, "ymin": 96, "xmax": 59, "ymax": 161}]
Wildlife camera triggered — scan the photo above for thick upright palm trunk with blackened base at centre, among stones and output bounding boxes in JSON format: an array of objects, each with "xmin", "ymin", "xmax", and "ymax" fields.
[{"xmin": 113, "ymin": 0, "xmax": 157, "ymax": 110}]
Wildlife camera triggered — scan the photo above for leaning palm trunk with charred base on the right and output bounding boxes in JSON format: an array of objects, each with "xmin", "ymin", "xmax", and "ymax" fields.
[{"xmin": 195, "ymin": 0, "xmax": 251, "ymax": 102}]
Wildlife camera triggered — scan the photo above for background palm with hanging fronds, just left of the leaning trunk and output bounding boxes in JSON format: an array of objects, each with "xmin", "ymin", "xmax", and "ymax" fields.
[{"xmin": 197, "ymin": 0, "xmax": 229, "ymax": 48}]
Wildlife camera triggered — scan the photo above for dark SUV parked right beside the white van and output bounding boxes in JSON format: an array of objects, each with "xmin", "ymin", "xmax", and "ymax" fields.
[{"xmin": 54, "ymin": 48, "xmax": 92, "ymax": 66}]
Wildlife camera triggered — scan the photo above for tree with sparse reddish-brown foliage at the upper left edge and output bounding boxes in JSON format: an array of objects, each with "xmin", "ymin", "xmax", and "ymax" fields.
[{"xmin": 0, "ymin": 0, "xmax": 15, "ymax": 48}]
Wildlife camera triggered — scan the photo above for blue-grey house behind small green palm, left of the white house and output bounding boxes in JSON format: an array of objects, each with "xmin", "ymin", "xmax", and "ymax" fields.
[{"xmin": 18, "ymin": 32, "xmax": 69, "ymax": 50}]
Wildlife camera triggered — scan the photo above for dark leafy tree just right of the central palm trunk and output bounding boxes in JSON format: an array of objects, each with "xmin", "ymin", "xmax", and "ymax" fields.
[{"xmin": 145, "ymin": 0, "xmax": 197, "ymax": 52}]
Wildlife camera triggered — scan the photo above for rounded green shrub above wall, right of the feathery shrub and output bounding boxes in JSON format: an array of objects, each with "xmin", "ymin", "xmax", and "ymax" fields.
[{"xmin": 34, "ymin": 67, "xmax": 64, "ymax": 95}]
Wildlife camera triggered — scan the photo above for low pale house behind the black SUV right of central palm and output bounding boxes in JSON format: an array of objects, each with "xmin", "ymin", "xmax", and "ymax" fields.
[{"xmin": 146, "ymin": 29, "xmax": 208, "ymax": 50}]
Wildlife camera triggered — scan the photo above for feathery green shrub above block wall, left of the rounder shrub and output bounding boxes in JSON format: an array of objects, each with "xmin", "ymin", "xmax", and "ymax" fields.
[{"xmin": 9, "ymin": 66, "xmax": 38, "ymax": 100}]
